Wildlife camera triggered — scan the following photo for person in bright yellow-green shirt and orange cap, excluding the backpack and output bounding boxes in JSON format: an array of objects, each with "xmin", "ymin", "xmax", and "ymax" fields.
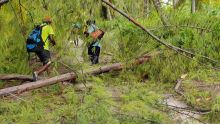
[{"xmin": 33, "ymin": 16, "xmax": 56, "ymax": 81}]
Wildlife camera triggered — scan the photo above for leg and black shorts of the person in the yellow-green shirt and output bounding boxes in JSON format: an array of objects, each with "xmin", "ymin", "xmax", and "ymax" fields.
[{"xmin": 33, "ymin": 50, "xmax": 51, "ymax": 81}]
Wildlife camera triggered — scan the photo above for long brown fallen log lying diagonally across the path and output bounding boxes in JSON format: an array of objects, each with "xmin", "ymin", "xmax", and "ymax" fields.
[{"xmin": 0, "ymin": 55, "xmax": 151, "ymax": 96}]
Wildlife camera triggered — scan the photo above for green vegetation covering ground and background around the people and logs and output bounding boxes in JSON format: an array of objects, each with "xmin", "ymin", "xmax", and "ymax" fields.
[{"xmin": 0, "ymin": 0, "xmax": 220, "ymax": 124}]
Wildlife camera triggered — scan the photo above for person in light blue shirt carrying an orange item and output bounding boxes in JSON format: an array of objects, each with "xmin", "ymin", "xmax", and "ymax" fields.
[{"xmin": 84, "ymin": 20, "xmax": 104, "ymax": 64}]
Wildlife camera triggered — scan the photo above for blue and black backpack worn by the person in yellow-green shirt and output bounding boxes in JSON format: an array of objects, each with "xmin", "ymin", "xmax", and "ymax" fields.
[{"xmin": 26, "ymin": 25, "xmax": 45, "ymax": 52}]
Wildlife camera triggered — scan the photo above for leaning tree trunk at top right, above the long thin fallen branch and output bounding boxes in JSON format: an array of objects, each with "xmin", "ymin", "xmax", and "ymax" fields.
[{"xmin": 152, "ymin": 0, "xmax": 170, "ymax": 26}]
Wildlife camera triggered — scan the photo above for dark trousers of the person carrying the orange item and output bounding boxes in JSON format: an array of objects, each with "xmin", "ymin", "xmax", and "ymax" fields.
[{"xmin": 88, "ymin": 44, "xmax": 101, "ymax": 64}]
